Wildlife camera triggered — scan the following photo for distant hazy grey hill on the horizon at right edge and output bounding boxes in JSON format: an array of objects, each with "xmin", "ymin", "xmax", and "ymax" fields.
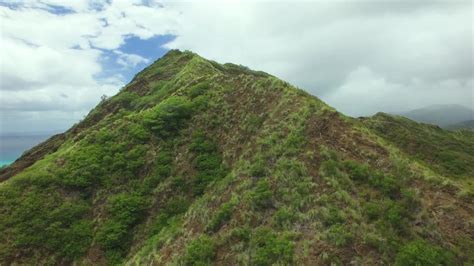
[{"xmin": 400, "ymin": 104, "xmax": 474, "ymax": 127}]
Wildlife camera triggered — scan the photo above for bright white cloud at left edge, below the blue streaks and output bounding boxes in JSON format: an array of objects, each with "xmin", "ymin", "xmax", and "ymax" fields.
[{"xmin": 0, "ymin": 38, "xmax": 101, "ymax": 90}]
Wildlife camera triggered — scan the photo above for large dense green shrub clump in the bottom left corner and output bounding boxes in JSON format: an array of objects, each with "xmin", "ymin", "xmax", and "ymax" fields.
[{"xmin": 12, "ymin": 197, "xmax": 93, "ymax": 260}]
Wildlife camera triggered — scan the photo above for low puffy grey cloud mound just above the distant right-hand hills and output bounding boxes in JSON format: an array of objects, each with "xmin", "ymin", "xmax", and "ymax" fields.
[{"xmin": 325, "ymin": 67, "xmax": 474, "ymax": 116}]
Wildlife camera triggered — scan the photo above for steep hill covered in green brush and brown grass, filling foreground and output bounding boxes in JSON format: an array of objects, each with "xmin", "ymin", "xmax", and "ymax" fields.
[{"xmin": 0, "ymin": 51, "xmax": 474, "ymax": 265}]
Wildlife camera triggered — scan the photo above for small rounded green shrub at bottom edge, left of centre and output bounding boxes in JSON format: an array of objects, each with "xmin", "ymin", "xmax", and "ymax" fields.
[{"xmin": 183, "ymin": 235, "xmax": 215, "ymax": 265}]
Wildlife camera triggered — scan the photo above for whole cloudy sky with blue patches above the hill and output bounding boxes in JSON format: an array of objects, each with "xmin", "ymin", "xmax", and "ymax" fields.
[{"xmin": 0, "ymin": 0, "xmax": 474, "ymax": 134}]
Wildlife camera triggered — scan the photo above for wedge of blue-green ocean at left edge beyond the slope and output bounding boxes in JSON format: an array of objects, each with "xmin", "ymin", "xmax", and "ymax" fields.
[{"xmin": 0, "ymin": 133, "xmax": 53, "ymax": 167}]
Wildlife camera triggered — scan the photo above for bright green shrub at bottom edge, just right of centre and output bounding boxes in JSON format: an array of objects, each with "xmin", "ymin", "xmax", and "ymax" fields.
[{"xmin": 251, "ymin": 227, "xmax": 294, "ymax": 265}]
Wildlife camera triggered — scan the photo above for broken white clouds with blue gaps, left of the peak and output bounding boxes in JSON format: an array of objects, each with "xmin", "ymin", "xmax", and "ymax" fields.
[{"xmin": 0, "ymin": 0, "xmax": 178, "ymax": 132}]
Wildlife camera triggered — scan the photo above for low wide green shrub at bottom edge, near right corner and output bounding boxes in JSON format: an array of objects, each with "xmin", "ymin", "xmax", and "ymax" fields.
[{"xmin": 395, "ymin": 240, "xmax": 453, "ymax": 266}]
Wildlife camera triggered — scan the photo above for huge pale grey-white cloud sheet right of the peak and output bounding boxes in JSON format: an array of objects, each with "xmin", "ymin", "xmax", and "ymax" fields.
[{"xmin": 162, "ymin": 0, "xmax": 473, "ymax": 115}]
